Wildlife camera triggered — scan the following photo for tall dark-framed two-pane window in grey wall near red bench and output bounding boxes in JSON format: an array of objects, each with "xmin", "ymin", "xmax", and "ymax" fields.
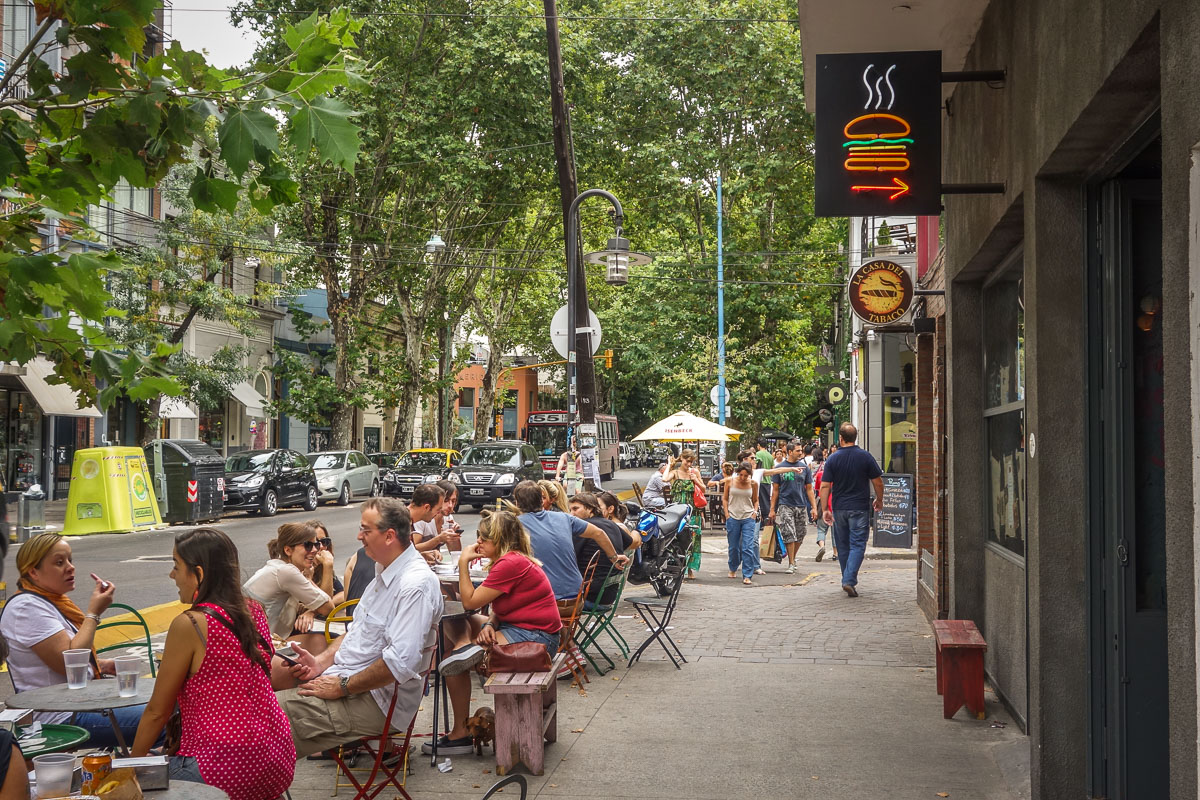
[{"xmin": 982, "ymin": 255, "xmax": 1025, "ymax": 555}]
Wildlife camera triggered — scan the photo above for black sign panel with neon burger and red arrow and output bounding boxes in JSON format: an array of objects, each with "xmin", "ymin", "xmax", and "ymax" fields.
[{"xmin": 816, "ymin": 50, "xmax": 942, "ymax": 217}]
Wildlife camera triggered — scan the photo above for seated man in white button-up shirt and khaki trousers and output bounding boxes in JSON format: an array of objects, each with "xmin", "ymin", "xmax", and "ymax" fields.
[{"xmin": 276, "ymin": 498, "xmax": 443, "ymax": 758}]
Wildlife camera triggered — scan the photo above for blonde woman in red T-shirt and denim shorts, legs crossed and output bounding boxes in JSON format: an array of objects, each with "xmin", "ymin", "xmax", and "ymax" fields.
[{"xmin": 425, "ymin": 511, "xmax": 563, "ymax": 756}]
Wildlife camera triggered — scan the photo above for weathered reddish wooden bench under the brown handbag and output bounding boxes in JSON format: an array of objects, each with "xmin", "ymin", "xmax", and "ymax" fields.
[{"xmin": 484, "ymin": 652, "xmax": 566, "ymax": 775}]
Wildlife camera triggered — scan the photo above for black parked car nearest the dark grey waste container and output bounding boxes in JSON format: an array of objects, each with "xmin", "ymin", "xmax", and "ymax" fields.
[{"xmin": 224, "ymin": 450, "xmax": 319, "ymax": 517}]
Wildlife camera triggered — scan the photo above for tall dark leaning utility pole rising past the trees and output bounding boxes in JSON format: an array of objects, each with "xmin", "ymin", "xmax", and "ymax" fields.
[{"xmin": 542, "ymin": 0, "xmax": 596, "ymax": 491}]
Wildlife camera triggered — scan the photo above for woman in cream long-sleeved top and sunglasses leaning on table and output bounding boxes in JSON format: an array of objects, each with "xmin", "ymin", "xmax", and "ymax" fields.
[{"xmin": 242, "ymin": 522, "xmax": 334, "ymax": 666}]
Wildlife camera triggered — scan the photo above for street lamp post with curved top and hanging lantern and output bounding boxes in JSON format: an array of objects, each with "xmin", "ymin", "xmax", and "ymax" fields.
[{"xmin": 566, "ymin": 188, "xmax": 650, "ymax": 492}]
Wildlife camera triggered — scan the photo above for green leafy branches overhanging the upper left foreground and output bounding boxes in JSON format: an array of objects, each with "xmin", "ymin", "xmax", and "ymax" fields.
[{"xmin": 0, "ymin": 0, "xmax": 361, "ymax": 407}]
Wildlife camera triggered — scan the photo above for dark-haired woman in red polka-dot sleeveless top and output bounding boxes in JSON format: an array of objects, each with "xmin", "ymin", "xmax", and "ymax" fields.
[{"xmin": 133, "ymin": 528, "xmax": 296, "ymax": 800}]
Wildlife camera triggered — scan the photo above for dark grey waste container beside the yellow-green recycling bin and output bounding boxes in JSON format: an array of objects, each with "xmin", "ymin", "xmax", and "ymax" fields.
[{"xmin": 145, "ymin": 439, "xmax": 224, "ymax": 523}]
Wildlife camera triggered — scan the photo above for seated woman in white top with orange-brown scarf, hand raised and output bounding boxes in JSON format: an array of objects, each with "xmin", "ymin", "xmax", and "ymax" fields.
[{"xmin": 0, "ymin": 533, "xmax": 145, "ymax": 747}]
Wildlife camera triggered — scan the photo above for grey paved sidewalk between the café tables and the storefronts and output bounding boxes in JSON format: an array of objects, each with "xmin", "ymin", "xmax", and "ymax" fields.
[{"xmin": 292, "ymin": 536, "xmax": 1028, "ymax": 800}]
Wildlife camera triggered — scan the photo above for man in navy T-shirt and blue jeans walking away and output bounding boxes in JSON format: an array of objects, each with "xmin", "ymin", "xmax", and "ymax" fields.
[{"xmin": 820, "ymin": 422, "xmax": 883, "ymax": 597}]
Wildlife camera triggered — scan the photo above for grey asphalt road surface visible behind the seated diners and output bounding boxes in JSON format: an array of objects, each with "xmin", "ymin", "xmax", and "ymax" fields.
[{"xmin": 4, "ymin": 469, "xmax": 650, "ymax": 608}]
